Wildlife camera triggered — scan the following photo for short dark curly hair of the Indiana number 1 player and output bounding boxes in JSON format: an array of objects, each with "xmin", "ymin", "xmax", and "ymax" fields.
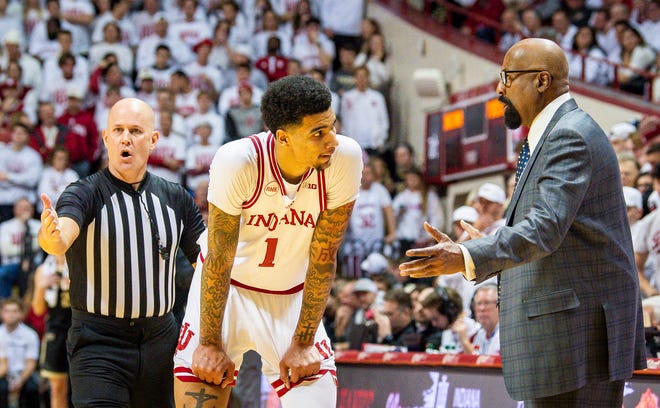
[{"xmin": 261, "ymin": 75, "xmax": 332, "ymax": 133}]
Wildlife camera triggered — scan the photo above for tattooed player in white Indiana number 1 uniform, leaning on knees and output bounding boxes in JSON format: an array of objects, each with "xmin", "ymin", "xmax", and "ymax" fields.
[{"xmin": 174, "ymin": 76, "xmax": 362, "ymax": 407}]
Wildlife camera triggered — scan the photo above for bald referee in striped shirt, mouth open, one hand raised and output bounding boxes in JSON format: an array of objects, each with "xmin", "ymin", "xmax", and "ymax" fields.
[{"xmin": 39, "ymin": 98, "xmax": 204, "ymax": 408}]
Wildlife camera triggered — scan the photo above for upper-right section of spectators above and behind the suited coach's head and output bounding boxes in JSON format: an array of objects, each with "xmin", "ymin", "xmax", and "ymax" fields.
[{"xmin": 431, "ymin": 0, "xmax": 660, "ymax": 102}]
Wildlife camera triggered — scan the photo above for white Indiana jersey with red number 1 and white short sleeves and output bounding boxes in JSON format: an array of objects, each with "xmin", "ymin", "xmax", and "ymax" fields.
[{"xmin": 208, "ymin": 132, "xmax": 362, "ymax": 294}]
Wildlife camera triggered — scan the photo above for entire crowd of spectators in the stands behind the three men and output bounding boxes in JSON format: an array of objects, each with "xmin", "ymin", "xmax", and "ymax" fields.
[{"xmin": 0, "ymin": 0, "xmax": 660, "ymax": 407}]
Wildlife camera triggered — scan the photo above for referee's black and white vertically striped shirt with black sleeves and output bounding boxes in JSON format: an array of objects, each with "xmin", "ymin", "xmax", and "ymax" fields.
[{"xmin": 56, "ymin": 169, "xmax": 204, "ymax": 318}]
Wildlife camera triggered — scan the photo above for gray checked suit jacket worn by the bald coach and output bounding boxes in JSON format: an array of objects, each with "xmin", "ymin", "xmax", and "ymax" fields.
[{"xmin": 463, "ymin": 99, "xmax": 646, "ymax": 400}]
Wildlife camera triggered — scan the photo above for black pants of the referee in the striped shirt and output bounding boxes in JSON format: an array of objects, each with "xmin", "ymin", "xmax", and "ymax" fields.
[{"xmin": 67, "ymin": 310, "xmax": 179, "ymax": 408}]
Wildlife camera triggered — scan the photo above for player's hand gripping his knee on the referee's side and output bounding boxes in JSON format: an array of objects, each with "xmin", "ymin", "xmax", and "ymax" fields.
[{"xmin": 192, "ymin": 344, "xmax": 235, "ymax": 388}]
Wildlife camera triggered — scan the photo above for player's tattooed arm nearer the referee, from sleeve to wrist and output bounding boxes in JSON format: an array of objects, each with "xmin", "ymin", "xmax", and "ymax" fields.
[{"xmin": 199, "ymin": 204, "xmax": 241, "ymax": 345}]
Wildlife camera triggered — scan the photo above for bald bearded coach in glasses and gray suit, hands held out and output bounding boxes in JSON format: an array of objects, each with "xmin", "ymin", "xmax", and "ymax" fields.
[{"xmin": 400, "ymin": 38, "xmax": 646, "ymax": 408}]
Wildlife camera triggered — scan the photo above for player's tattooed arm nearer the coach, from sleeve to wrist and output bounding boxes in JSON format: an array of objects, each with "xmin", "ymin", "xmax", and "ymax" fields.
[{"xmin": 293, "ymin": 201, "xmax": 355, "ymax": 345}]
